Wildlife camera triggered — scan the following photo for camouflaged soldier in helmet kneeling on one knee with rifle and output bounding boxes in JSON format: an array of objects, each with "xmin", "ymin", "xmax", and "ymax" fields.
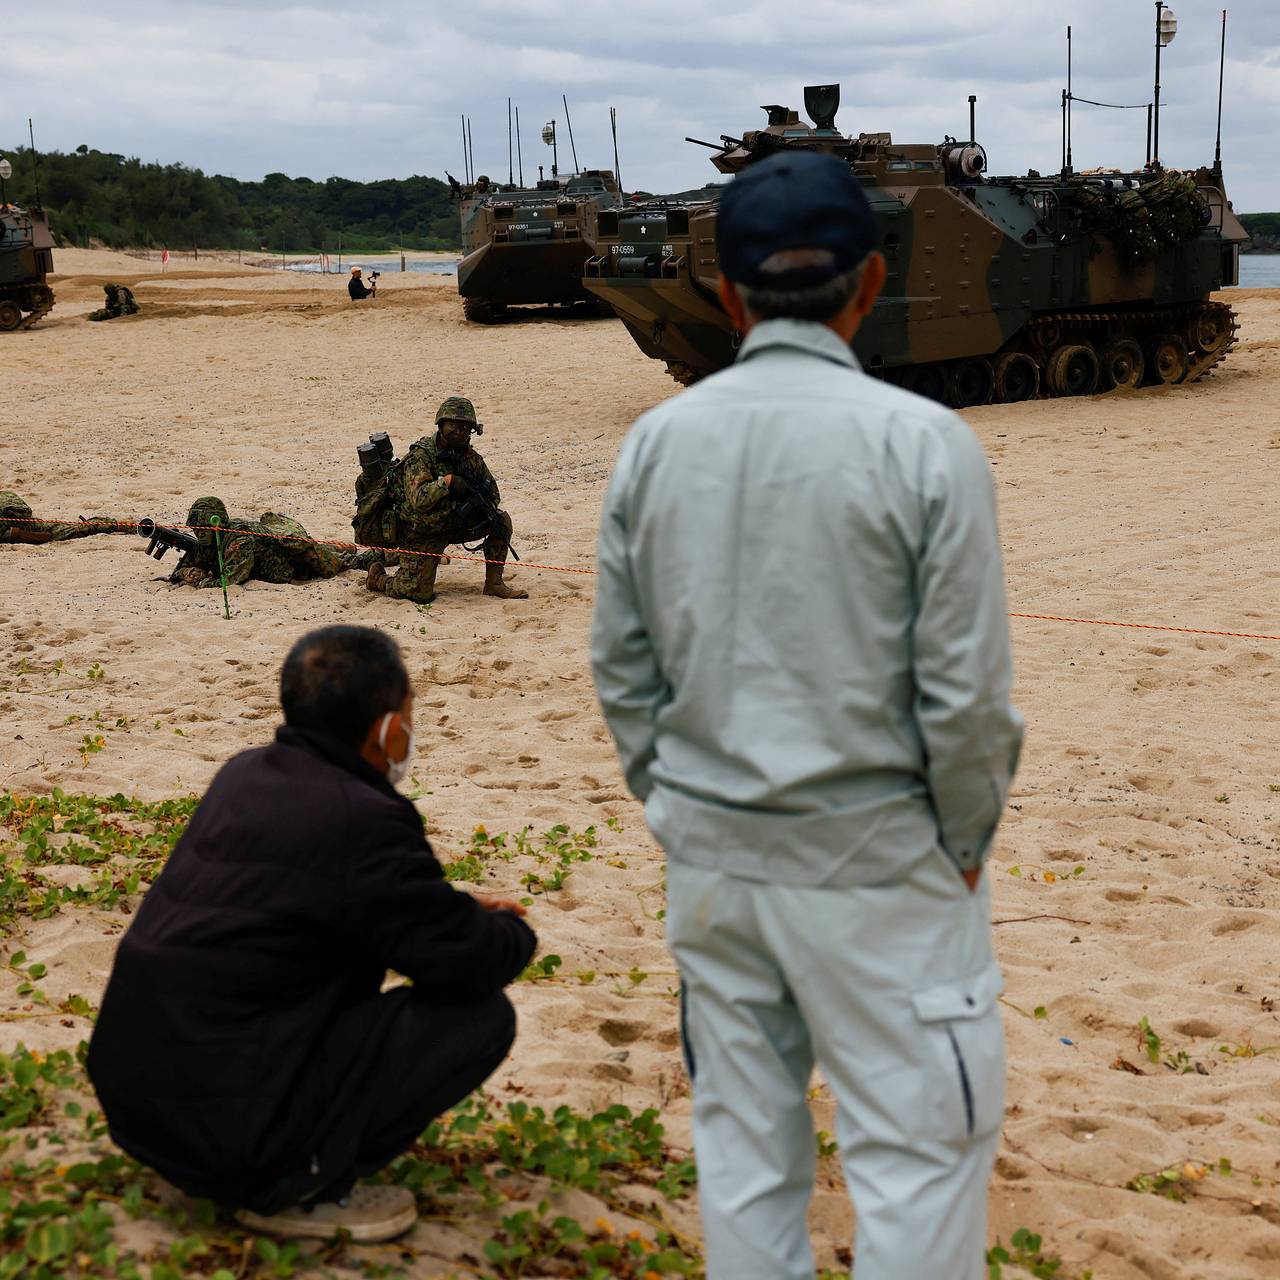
[{"xmin": 365, "ymin": 396, "xmax": 529, "ymax": 604}]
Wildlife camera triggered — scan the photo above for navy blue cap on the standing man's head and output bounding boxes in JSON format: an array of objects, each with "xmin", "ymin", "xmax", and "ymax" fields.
[{"xmin": 716, "ymin": 150, "xmax": 879, "ymax": 289}]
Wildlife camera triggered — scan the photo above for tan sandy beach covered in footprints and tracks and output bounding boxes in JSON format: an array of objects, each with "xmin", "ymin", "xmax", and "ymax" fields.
[{"xmin": 0, "ymin": 250, "xmax": 1280, "ymax": 1280}]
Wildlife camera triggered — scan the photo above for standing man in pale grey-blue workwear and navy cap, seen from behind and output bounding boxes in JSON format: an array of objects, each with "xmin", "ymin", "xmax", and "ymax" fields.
[{"xmin": 591, "ymin": 154, "xmax": 1021, "ymax": 1280}]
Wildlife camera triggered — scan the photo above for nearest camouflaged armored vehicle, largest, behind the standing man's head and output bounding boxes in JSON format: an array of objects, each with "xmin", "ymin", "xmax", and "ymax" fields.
[{"xmin": 584, "ymin": 84, "xmax": 1247, "ymax": 407}]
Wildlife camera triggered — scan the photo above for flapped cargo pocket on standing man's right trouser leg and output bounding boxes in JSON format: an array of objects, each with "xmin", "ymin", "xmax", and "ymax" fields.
[{"xmin": 911, "ymin": 961, "xmax": 1005, "ymax": 1142}]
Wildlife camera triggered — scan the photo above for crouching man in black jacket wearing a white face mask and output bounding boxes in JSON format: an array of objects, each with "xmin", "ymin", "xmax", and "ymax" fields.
[{"xmin": 88, "ymin": 626, "xmax": 536, "ymax": 1240}]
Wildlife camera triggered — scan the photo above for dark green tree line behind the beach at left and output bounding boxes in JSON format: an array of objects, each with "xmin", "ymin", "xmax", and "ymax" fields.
[{"xmin": 0, "ymin": 146, "xmax": 460, "ymax": 253}]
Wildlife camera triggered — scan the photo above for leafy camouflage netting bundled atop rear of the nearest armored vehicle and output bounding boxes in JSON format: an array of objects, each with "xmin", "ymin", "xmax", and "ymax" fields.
[{"xmin": 1071, "ymin": 169, "xmax": 1211, "ymax": 264}]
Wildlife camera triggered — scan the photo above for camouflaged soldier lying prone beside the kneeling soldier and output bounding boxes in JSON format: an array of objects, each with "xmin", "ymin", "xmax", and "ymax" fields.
[{"xmin": 169, "ymin": 498, "xmax": 369, "ymax": 586}]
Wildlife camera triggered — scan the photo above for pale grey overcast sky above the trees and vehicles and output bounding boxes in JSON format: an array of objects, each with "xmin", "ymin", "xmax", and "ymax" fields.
[{"xmin": 10, "ymin": 0, "xmax": 1280, "ymax": 211}]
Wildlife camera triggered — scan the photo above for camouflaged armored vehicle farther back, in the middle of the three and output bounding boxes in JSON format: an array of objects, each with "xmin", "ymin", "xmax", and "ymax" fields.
[{"xmin": 457, "ymin": 169, "xmax": 621, "ymax": 324}]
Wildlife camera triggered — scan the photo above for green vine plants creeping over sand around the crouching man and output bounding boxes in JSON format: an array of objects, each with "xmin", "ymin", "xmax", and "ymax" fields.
[{"xmin": 0, "ymin": 793, "xmax": 1084, "ymax": 1280}]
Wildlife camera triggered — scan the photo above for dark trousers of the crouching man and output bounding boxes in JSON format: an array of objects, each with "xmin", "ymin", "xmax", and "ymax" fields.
[{"xmin": 254, "ymin": 987, "xmax": 516, "ymax": 1213}]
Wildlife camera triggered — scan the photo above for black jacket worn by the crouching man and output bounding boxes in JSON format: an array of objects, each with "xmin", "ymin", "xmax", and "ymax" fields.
[{"xmin": 88, "ymin": 727, "xmax": 536, "ymax": 1203}]
